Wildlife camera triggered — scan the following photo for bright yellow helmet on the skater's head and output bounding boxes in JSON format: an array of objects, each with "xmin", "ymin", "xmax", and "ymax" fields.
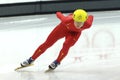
[{"xmin": 73, "ymin": 9, "xmax": 88, "ymax": 22}]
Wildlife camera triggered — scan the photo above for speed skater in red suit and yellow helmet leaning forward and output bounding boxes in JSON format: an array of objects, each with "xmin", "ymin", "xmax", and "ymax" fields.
[{"xmin": 20, "ymin": 9, "xmax": 93, "ymax": 70}]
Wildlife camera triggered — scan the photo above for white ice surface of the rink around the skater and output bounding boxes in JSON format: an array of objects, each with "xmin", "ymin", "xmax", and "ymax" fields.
[{"xmin": 0, "ymin": 11, "xmax": 120, "ymax": 80}]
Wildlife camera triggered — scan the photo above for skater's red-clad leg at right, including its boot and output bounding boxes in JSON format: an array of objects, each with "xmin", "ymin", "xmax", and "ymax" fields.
[{"xmin": 49, "ymin": 33, "xmax": 80, "ymax": 70}]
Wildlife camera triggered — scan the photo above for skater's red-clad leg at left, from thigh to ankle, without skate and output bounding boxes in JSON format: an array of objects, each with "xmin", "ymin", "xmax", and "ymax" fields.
[{"xmin": 32, "ymin": 25, "xmax": 64, "ymax": 60}]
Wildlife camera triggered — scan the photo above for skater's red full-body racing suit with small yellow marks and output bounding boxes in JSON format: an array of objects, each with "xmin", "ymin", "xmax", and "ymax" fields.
[{"xmin": 32, "ymin": 12, "xmax": 93, "ymax": 63}]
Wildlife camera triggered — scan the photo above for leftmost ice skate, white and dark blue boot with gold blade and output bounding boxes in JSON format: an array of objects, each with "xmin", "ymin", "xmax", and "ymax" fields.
[{"xmin": 15, "ymin": 57, "xmax": 34, "ymax": 71}]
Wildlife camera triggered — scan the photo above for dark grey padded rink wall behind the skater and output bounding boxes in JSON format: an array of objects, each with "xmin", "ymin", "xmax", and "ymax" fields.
[{"xmin": 0, "ymin": 0, "xmax": 120, "ymax": 17}]
